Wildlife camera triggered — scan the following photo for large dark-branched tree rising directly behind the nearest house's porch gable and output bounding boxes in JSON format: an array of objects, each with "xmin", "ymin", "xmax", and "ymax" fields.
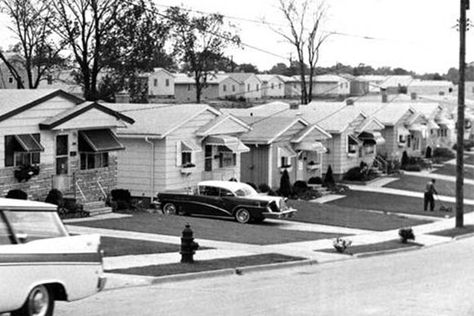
[{"xmin": 49, "ymin": 0, "xmax": 120, "ymax": 100}]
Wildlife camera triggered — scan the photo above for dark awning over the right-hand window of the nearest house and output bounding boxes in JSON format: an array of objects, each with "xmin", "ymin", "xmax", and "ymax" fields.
[{"xmin": 79, "ymin": 129, "xmax": 125, "ymax": 152}]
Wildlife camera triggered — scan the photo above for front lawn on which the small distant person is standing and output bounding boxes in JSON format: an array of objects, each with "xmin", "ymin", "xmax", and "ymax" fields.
[{"xmin": 329, "ymin": 191, "xmax": 458, "ymax": 217}]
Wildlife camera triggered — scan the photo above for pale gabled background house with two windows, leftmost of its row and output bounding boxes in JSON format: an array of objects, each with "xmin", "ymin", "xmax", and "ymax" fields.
[{"xmin": 148, "ymin": 68, "xmax": 175, "ymax": 102}]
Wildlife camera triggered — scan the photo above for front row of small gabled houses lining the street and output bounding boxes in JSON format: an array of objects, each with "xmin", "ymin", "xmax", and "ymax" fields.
[{"xmin": 0, "ymin": 90, "xmax": 460, "ymax": 207}]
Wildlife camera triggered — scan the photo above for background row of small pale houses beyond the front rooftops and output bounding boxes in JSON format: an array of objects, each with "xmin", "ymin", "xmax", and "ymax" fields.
[{"xmin": 143, "ymin": 68, "xmax": 368, "ymax": 103}]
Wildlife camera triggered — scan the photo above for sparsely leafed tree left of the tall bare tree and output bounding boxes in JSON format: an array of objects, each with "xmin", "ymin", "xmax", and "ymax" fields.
[{"xmin": 166, "ymin": 7, "xmax": 240, "ymax": 103}]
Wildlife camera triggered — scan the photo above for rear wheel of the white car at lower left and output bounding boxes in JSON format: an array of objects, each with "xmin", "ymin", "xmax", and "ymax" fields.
[{"xmin": 12, "ymin": 285, "xmax": 54, "ymax": 316}]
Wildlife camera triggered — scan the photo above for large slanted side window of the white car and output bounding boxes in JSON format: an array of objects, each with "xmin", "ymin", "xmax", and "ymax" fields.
[{"xmin": 3, "ymin": 211, "xmax": 67, "ymax": 241}]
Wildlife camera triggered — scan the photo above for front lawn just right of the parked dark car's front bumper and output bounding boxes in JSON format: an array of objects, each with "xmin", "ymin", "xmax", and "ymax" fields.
[{"xmin": 288, "ymin": 201, "xmax": 429, "ymax": 231}]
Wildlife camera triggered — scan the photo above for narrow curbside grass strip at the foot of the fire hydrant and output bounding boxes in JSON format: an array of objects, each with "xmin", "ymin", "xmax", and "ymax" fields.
[{"xmin": 107, "ymin": 253, "xmax": 304, "ymax": 277}]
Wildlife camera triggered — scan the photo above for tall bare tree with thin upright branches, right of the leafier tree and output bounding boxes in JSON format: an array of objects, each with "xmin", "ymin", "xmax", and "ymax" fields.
[{"xmin": 274, "ymin": 0, "xmax": 331, "ymax": 104}]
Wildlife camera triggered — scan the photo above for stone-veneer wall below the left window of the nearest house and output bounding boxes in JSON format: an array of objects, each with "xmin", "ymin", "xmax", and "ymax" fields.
[{"xmin": 0, "ymin": 164, "xmax": 55, "ymax": 201}]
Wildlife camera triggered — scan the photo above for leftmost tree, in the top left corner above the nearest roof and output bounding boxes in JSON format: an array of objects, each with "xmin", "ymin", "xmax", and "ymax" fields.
[{"xmin": 0, "ymin": 0, "xmax": 64, "ymax": 89}]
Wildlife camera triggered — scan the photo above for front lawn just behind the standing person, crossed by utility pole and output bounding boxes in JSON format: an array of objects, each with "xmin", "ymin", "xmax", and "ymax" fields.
[{"xmin": 385, "ymin": 175, "xmax": 474, "ymax": 199}]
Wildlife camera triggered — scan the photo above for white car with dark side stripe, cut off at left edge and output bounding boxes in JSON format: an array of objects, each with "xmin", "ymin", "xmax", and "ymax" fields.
[{"xmin": 0, "ymin": 198, "xmax": 105, "ymax": 316}]
